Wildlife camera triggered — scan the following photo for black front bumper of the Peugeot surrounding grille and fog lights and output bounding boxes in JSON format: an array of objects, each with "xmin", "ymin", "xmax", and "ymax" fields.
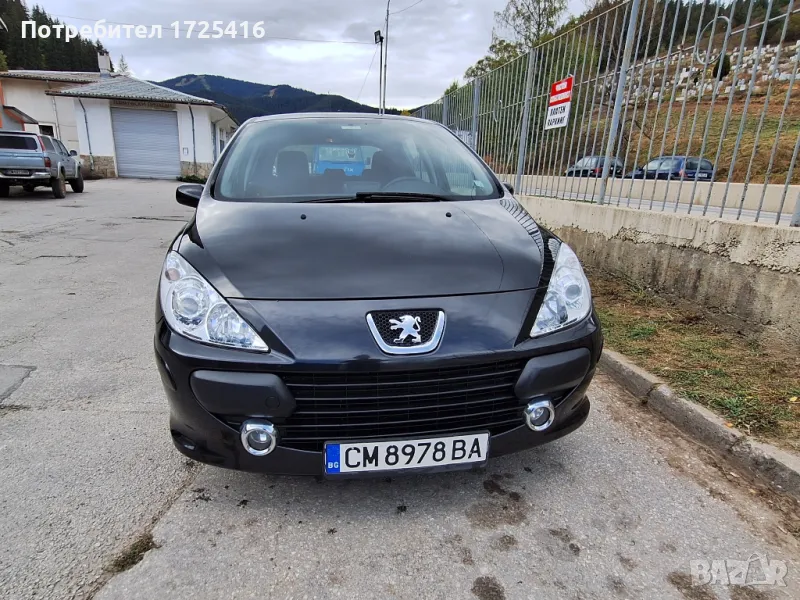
[{"xmin": 155, "ymin": 314, "xmax": 602, "ymax": 475}]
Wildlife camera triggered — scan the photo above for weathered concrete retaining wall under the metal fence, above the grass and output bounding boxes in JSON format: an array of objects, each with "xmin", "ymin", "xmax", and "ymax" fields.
[{"xmin": 519, "ymin": 196, "xmax": 800, "ymax": 347}]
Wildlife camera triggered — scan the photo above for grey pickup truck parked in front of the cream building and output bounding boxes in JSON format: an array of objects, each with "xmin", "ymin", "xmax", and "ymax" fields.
[{"xmin": 0, "ymin": 131, "xmax": 83, "ymax": 198}]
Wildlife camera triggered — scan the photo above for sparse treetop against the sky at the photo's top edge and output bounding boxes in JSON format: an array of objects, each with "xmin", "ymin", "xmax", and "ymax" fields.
[{"xmin": 494, "ymin": 0, "xmax": 567, "ymax": 50}]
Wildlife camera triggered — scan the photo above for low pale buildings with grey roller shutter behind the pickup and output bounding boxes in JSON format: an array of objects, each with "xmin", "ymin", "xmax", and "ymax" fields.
[{"xmin": 0, "ymin": 58, "xmax": 237, "ymax": 179}]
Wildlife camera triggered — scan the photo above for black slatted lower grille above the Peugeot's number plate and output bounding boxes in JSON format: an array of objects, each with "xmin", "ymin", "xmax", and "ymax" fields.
[{"xmin": 279, "ymin": 361, "xmax": 525, "ymax": 451}]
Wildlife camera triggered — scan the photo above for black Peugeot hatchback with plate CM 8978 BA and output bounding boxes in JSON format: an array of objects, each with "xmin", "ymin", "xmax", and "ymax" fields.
[{"xmin": 155, "ymin": 114, "xmax": 602, "ymax": 477}]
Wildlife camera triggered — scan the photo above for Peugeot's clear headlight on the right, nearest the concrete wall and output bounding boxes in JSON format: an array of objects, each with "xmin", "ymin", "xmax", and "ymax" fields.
[{"xmin": 531, "ymin": 243, "xmax": 592, "ymax": 337}]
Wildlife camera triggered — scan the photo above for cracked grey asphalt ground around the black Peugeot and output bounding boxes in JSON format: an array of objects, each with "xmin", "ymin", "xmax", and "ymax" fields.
[{"xmin": 0, "ymin": 180, "xmax": 800, "ymax": 600}]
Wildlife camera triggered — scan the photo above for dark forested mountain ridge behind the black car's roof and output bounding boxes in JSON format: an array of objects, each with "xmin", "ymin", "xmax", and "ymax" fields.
[{"xmin": 154, "ymin": 73, "xmax": 399, "ymax": 122}]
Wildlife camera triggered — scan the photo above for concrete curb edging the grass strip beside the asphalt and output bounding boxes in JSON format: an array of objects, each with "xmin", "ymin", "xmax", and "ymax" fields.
[{"xmin": 600, "ymin": 349, "xmax": 800, "ymax": 500}]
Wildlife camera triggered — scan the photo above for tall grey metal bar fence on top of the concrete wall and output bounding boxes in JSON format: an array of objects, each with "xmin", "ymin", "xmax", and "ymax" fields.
[{"xmin": 415, "ymin": 0, "xmax": 800, "ymax": 226}]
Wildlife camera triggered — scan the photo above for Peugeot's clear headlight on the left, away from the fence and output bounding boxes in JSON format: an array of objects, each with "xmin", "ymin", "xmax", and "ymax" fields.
[{"xmin": 158, "ymin": 252, "xmax": 269, "ymax": 352}]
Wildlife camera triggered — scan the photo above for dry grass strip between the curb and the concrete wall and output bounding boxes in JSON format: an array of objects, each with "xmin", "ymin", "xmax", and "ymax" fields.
[{"xmin": 589, "ymin": 272, "xmax": 800, "ymax": 451}]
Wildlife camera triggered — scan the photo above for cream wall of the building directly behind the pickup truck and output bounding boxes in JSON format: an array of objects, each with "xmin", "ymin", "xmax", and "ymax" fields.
[{"xmin": 3, "ymin": 78, "xmax": 79, "ymax": 150}]
